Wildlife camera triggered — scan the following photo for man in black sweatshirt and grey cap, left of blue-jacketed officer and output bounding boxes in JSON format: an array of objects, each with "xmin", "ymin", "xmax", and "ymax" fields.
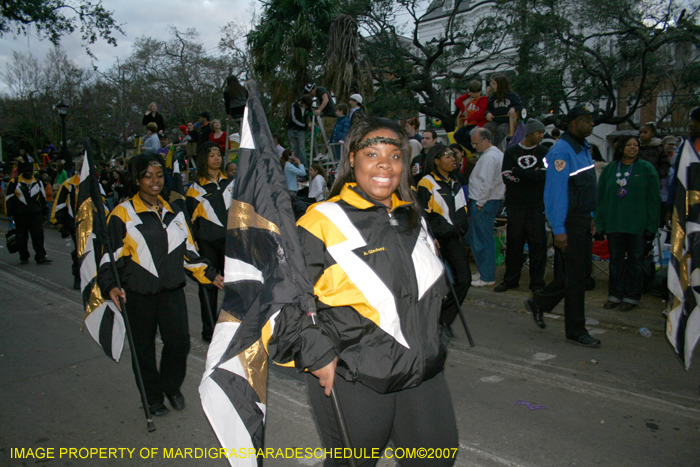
[{"xmin": 493, "ymin": 119, "xmax": 547, "ymax": 293}]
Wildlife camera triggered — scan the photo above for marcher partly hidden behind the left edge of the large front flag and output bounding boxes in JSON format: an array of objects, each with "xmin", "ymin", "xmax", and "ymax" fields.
[{"xmin": 186, "ymin": 141, "xmax": 233, "ymax": 342}]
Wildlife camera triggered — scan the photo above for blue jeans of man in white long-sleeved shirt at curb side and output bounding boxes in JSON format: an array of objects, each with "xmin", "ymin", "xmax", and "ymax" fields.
[{"xmin": 467, "ymin": 199, "xmax": 501, "ymax": 282}]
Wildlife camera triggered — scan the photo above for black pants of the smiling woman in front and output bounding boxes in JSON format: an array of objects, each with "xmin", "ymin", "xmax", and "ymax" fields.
[{"xmin": 306, "ymin": 373, "xmax": 459, "ymax": 467}]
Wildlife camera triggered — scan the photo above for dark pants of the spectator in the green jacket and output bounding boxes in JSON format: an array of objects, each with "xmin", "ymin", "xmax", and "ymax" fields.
[{"xmin": 607, "ymin": 232, "xmax": 645, "ymax": 305}]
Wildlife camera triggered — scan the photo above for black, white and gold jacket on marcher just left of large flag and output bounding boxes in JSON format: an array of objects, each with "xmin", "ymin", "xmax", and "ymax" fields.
[{"xmin": 186, "ymin": 173, "xmax": 234, "ymax": 242}]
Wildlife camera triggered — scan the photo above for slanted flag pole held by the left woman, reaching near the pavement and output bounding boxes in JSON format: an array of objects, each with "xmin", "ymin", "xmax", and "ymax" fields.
[{"xmin": 85, "ymin": 139, "xmax": 156, "ymax": 433}]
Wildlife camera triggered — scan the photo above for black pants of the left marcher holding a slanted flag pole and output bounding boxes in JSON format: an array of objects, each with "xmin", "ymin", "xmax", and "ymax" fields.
[{"xmin": 126, "ymin": 289, "xmax": 190, "ymax": 404}]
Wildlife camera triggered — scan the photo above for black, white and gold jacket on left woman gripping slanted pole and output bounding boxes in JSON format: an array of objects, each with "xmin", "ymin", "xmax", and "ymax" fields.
[{"xmin": 97, "ymin": 194, "xmax": 217, "ymax": 296}]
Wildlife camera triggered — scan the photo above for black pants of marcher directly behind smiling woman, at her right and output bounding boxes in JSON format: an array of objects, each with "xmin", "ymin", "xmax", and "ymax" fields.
[{"xmin": 439, "ymin": 235, "xmax": 472, "ymax": 324}]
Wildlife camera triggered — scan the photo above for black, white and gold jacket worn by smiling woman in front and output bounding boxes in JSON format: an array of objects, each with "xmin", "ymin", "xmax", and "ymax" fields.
[{"xmin": 297, "ymin": 183, "xmax": 446, "ymax": 393}]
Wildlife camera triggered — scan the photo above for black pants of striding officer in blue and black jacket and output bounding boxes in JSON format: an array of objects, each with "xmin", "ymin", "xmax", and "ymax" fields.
[{"xmin": 534, "ymin": 215, "xmax": 593, "ymax": 339}]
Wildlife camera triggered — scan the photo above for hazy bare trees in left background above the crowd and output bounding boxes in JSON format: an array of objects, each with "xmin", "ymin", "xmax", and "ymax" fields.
[{"xmin": 0, "ymin": 28, "xmax": 244, "ymax": 163}]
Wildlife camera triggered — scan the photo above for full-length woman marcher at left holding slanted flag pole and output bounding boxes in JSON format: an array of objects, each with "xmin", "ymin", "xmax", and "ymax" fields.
[{"xmin": 97, "ymin": 154, "xmax": 223, "ymax": 415}]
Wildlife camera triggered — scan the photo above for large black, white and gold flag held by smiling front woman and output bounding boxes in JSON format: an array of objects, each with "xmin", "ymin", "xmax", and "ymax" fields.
[{"xmin": 199, "ymin": 81, "xmax": 315, "ymax": 466}]
